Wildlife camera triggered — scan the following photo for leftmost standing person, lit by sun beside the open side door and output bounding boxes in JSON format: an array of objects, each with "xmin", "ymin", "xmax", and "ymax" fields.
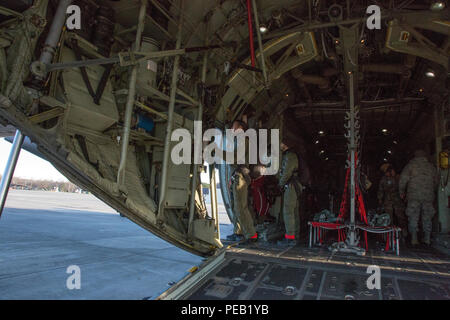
[{"xmin": 227, "ymin": 121, "xmax": 258, "ymax": 241}]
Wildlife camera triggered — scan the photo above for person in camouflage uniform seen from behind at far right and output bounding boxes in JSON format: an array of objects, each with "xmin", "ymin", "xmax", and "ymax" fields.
[{"xmin": 399, "ymin": 150, "xmax": 438, "ymax": 245}]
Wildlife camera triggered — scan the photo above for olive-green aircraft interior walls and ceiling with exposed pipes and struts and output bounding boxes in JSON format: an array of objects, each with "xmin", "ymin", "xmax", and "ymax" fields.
[{"xmin": 0, "ymin": 0, "xmax": 450, "ymax": 256}]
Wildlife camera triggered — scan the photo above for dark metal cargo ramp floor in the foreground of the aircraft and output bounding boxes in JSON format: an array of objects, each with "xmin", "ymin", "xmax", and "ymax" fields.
[{"xmin": 159, "ymin": 244, "xmax": 450, "ymax": 300}]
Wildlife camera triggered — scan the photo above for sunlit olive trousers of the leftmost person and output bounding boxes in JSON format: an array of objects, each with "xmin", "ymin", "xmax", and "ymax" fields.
[{"xmin": 231, "ymin": 172, "xmax": 256, "ymax": 239}]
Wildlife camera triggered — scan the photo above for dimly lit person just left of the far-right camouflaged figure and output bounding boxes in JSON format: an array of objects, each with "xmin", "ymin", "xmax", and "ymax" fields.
[{"xmin": 378, "ymin": 165, "xmax": 408, "ymax": 239}]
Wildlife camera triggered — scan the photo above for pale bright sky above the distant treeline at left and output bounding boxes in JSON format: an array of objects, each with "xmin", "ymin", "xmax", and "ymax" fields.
[{"xmin": 0, "ymin": 138, "xmax": 68, "ymax": 181}]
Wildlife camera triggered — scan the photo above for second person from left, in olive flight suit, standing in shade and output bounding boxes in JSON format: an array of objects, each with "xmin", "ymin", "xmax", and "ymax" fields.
[{"xmin": 278, "ymin": 143, "xmax": 302, "ymax": 246}]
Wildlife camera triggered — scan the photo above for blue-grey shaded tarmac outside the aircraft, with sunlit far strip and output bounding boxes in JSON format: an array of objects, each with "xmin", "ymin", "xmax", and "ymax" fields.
[{"xmin": 0, "ymin": 190, "xmax": 232, "ymax": 300}]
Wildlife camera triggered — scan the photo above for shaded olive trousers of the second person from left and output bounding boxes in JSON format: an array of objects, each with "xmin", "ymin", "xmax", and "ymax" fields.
[{"xmin": 281, "ymin": 183, "xmax": 300, "ymax": 238}]
